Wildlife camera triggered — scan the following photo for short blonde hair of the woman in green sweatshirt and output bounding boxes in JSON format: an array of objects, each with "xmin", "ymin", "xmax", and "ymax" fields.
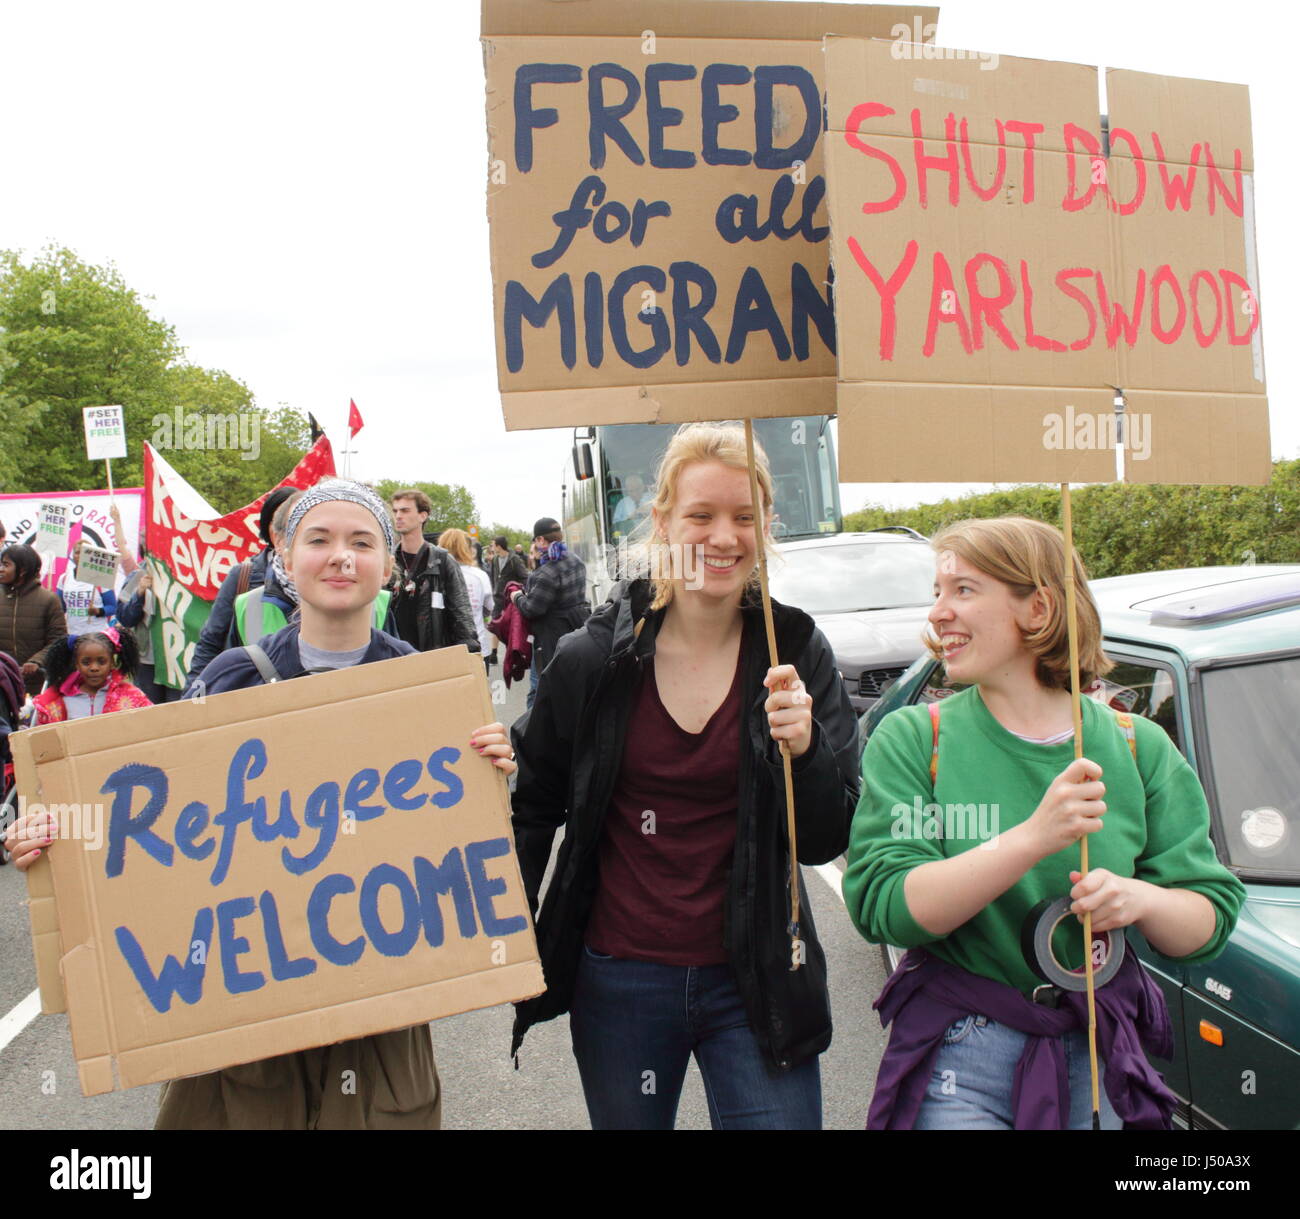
[{"xmin": 924, "ymin": 516, "xmax": 1114, "ymax": 690}]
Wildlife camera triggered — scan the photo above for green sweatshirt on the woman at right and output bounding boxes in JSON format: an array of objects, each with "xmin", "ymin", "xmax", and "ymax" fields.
[{"xmin": 844, "ymin": 687, "xmax": 1245, "ymax": 993}]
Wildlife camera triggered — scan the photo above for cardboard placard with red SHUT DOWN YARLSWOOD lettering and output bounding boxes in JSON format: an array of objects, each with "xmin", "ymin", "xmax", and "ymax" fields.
[{"xmin": 826, "ymin": 38, "xmax": 1271, "ymax": 483}]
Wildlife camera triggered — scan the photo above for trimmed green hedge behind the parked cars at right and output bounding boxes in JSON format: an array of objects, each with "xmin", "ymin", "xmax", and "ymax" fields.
[{"xmin": 844, "ymin": 460, "xmax": 1300, "ymax": 578}]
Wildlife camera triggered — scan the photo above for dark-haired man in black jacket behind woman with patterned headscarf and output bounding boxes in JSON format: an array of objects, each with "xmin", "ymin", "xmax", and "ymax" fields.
[{"xmin": 390, "ymin": 489, "xmax": 478, "ymax": 652}]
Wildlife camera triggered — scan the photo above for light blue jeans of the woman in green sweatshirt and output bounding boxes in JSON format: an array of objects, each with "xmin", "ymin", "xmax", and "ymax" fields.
[{"xmin": 913, "ymin": 1016, "xmax": 1123, "ymax": 1131}]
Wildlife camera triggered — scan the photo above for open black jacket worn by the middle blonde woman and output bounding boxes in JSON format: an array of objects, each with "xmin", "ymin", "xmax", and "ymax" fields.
[{"xmin": 511, "ymin": 581, "xmax": 859, "ymax": 1067}]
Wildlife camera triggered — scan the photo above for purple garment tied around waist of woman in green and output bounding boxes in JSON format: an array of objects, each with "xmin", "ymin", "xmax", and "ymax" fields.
[{"xmin": 867, "ymin": 949, "xmax": 1177, "ymax": 1131}]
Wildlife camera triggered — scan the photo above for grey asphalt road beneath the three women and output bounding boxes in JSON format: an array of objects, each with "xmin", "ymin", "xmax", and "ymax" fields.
[{"xmin": 0, "ymin": 670, "xmax": 884, "ymax": 1131}]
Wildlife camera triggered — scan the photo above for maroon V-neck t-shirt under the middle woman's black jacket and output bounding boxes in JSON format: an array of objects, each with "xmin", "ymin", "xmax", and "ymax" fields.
[{"xmin": 586, "ymin": 648, "xmax": 744, "ymax": 966}]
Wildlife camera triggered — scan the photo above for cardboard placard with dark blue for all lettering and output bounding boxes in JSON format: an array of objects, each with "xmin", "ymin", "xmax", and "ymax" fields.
[{"xmin": 482, "ymin": 0, "xmax": 937, "ymax": 429}]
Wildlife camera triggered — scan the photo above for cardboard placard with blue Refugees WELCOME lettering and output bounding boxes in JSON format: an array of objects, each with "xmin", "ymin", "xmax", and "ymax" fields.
[{"xmin": 13, "ymin": 648, "xmax": 543, "ymax": 1096}]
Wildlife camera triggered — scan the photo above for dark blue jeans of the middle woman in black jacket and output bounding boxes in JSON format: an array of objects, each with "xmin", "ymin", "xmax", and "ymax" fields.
[{"xmin": 569, "ymin": 949, "xmax": 822, "ymax": 1131}]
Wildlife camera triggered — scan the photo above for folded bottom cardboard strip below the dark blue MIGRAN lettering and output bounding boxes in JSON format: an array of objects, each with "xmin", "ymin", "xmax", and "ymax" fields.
[{"xmin": 501, "ymin": 377, "xmax": 836, "ymax": 431}]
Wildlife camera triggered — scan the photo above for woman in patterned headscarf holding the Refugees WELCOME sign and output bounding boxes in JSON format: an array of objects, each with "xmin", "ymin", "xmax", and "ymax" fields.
[{"xmin": 8, "ymin": 480, "xmax": 515, "ymax": 1129}]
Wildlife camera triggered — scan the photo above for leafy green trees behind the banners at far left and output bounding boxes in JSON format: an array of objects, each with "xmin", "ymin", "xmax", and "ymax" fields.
[{"xmin": 0, "ymin": 247, "xmax": 319, "ymax": 512}]
